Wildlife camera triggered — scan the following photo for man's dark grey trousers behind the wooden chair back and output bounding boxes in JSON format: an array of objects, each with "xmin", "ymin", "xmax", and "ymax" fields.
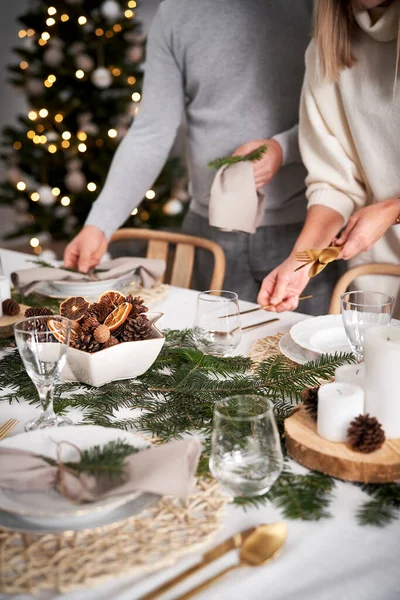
[{"xmin": 182, "ymin": 211, "xmax": 342, "ymax": 316}]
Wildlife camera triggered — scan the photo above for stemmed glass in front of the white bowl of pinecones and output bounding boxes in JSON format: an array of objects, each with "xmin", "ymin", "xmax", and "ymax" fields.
[{"xmin": 14, "ymin": 316, "xmax": 73, "ymax": 431}]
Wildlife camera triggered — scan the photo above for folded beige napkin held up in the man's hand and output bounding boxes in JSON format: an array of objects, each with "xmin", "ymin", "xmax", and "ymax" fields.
[{"xmin": 208, "ymin": 161, "xmax": 265, "ymax": 233}]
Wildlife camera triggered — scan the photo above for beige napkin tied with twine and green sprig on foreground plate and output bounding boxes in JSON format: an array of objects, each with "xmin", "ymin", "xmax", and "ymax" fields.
[{"xmin": 0, "ymin": 438, "xmax": 201, "ymax": 503}]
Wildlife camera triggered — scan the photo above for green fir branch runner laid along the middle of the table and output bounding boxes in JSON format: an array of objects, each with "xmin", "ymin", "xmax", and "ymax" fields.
[{"xmin": 0, "ymin": 330, "xmax": 400, "ymax": 526}]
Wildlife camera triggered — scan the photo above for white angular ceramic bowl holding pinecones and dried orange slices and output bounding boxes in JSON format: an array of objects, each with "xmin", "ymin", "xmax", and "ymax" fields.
[{"xmin": 62, "ymin": 313, "xmax": 165, "ymax": 387}]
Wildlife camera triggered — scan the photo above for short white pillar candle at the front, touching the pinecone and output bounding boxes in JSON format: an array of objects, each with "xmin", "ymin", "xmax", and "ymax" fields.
[{"xmin": 317, "ymin": 383, "xmax": 364, "ymax": 442}]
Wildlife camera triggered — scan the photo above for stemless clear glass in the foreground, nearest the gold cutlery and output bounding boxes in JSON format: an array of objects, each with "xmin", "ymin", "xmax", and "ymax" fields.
[{"xmin": 210, "ymin": 395, "xmax": 283, "ymax": 496}]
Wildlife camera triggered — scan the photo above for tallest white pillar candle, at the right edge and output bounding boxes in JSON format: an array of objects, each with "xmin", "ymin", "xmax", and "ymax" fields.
[{"xmin": 364, "ymin": 326, "xmax": 400, "ymax": 438}]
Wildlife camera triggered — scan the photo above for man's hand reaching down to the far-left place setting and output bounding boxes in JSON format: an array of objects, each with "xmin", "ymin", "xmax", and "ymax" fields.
[{"xmin": 64, "ymin": 225, "xmax": 108, "ymax": 273}]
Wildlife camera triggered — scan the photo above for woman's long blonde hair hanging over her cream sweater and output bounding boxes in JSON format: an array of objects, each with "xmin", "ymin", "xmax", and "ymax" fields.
[{"xmin": 314, "ymin": 0, "xmax": 354, "ymax": 81}]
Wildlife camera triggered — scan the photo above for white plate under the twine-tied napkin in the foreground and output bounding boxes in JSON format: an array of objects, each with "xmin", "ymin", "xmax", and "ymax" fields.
[{"xmin": 0, "ymin": 425, "xmax": 156, "ymax": 529}]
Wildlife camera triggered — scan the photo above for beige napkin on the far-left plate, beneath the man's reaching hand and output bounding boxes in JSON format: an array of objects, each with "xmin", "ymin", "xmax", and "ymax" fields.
[{"xmin": 11, "ymin": 256, "xmax": 165, "ymax": 295}]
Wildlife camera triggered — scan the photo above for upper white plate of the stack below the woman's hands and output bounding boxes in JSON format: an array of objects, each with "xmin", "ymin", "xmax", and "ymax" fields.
[{"xmin": 290, "ymin": 315, "xmax": 400, "ymax": 354}]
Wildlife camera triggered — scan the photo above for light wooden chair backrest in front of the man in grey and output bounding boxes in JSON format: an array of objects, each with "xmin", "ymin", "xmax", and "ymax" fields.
[{"xmin": 111, "ymin": 228, "xmax": 226, "ymax": 290}]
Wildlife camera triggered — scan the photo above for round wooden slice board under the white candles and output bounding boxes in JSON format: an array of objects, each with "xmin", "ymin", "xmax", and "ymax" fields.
[{"xmin": 285, "ymin": 406, "xmax": 400, "ymax": 483}]
